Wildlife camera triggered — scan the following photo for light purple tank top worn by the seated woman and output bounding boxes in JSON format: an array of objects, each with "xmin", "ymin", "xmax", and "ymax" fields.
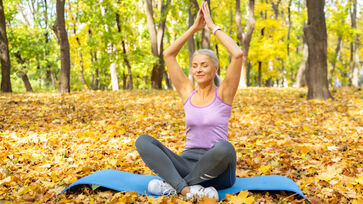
[{"xmin": 184, "ymin": 87, "xmax": 232, "ymax": 150}]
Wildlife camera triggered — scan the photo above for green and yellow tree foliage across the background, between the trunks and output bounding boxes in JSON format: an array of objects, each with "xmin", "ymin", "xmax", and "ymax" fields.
[{"xmin": 4, "ymin": 0, "xmax": 363, "ymax": 91}]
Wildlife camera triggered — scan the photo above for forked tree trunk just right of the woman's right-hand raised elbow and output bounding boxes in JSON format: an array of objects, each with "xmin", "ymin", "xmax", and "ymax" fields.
[{"xmin": 235, "ymin": 0, "xmax": 255, "ymax": 88}]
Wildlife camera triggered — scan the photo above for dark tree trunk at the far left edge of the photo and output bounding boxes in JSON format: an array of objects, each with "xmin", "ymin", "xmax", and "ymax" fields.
[{"xmin": 0, "ymin": 0, "xmax": 12, "ymax": 92}]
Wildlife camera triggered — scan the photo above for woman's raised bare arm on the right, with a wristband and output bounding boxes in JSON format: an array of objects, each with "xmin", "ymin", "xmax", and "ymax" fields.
[{"xmin": 201, "ymin": 2, "xmax": 243, "ymax": 104}]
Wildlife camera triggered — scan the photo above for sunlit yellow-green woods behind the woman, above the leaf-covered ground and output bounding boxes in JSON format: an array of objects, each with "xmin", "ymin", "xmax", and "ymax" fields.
[{"xmin": 0, "ymin": 0, "xmax": 363, "ymax": 92}]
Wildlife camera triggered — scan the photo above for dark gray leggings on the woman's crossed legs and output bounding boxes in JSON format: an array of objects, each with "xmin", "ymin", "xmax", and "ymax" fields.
[{"xmin": 135, "ymin": 135, "xmax": 236, "ymax": 193}]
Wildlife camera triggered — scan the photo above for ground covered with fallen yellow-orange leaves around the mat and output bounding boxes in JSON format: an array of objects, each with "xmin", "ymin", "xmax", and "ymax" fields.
[{"xmin": 0, "ymin": 88, "xmax": 363, "ymax": 203}]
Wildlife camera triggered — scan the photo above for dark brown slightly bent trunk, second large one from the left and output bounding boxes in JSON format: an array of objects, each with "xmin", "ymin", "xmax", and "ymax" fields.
[{"xmin": 53, "ymin": 0, "xmax": 71, "ymax": 93}]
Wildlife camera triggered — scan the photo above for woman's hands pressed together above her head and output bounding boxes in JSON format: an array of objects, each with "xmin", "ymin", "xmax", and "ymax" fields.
[{"xmin": 193, "ymin": 1, "xmax": 215, "ymax": 31}]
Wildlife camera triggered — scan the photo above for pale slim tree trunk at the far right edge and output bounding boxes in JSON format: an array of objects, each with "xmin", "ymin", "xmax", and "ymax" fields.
[{"xmin": 349, "ymin": 0, "xmax": 359, "ymax": 86}]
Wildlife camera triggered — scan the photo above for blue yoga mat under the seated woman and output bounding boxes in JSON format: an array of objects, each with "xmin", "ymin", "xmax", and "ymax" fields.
[{"xmin": 62, "ymin": 169, "xmax": 306, "ymax": 200}]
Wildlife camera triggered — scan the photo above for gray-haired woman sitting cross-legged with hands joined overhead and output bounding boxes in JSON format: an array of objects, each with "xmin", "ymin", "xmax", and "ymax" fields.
[{"xmin": 135, "ymin": 2, "xmax": 242, "ymax": 200}]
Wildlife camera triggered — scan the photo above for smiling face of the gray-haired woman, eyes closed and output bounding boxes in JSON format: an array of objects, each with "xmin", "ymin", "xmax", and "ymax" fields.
[{"xmin": 192, "ymin": 54, "xmax": 218, "ymax": 84}]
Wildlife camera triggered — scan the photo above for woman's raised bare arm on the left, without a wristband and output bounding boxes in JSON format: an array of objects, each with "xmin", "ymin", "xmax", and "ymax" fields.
[{"xmin": 163, "ymin": 5, "xmax": 206, "ymax": 103}]
